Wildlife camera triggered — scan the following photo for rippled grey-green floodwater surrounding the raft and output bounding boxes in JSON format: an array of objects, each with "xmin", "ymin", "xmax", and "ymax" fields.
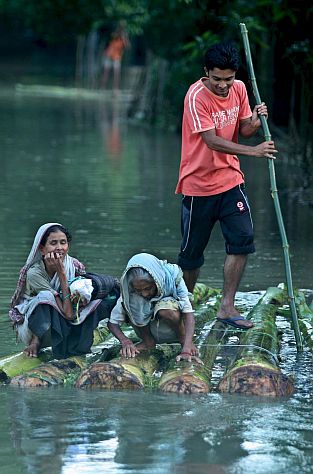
[{"xmin": 0, "ymin": 89, "xmax": 313, "ymax": 474}]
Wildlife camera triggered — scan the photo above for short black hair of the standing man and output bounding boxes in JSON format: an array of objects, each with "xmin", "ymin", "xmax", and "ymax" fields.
[{"xmin": 204, "ymin": 41, "xmax": 240, "ymax": 71}]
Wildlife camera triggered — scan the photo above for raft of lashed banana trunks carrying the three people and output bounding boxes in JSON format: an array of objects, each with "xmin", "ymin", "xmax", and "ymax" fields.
[{"xmin": 0, "ymin": 284, "xmax": 306, "ymax": 397}]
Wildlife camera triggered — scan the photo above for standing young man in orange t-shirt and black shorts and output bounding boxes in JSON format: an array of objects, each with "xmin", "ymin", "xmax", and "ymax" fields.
[{"xmin": 176, "ymin": 42, "xmax": 277, "ymax": 329}]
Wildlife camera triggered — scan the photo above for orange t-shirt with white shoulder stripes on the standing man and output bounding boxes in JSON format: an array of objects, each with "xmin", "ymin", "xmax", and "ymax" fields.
[{"xmin": 176, "ymin": 78, "xmax": 252, "ymax": 196}]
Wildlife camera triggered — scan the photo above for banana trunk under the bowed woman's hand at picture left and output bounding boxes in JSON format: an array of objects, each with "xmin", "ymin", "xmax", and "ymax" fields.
[{"xmin": 75, "ymin": 349, "xmax": 164, "ymax": 390}]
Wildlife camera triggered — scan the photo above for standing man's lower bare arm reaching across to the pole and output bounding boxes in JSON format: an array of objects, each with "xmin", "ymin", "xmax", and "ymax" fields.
[{"xmin": 200, "ymin": 129, "xmax": 277, "ymax": 158}]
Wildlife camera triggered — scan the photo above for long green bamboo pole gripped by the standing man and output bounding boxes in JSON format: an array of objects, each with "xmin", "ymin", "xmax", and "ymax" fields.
[{"xmin": 240, "ymin": 23, "xmax": 303, "ymax": 352}]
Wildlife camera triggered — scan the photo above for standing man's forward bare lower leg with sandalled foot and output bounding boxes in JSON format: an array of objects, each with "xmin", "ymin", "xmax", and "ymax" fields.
[{"xmin": 217, "ymin": 255, "xmax": 253, "ymax": 328}]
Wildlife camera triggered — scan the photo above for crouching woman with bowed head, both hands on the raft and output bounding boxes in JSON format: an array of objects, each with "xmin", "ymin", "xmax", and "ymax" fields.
[{"xmin": 108, "ymin": 253, "xmax": 198, "ymax": 361}]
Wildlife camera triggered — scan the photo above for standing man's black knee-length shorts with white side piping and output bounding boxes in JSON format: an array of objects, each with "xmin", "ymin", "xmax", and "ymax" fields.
[{"xmin": 178, "ymin": 184, "xmax": 255, "ymax": 270}]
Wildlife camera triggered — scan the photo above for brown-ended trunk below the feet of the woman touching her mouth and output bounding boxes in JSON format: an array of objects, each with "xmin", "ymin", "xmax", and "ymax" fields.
[{"xmin": 10, "ymin": 356, "xmax": 86, "ymax": 388}]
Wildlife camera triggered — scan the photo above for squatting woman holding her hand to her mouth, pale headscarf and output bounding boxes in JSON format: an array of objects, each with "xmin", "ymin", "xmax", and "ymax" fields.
[{"xmin": 9, "ymin": 223, "xmax": 119, "ymax": 359}]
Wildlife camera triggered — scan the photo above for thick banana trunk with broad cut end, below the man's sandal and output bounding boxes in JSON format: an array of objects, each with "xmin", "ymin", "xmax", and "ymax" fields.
[{"xmin": 218, "ymin": 288, "xmax": 294, "ymax": 397}]
